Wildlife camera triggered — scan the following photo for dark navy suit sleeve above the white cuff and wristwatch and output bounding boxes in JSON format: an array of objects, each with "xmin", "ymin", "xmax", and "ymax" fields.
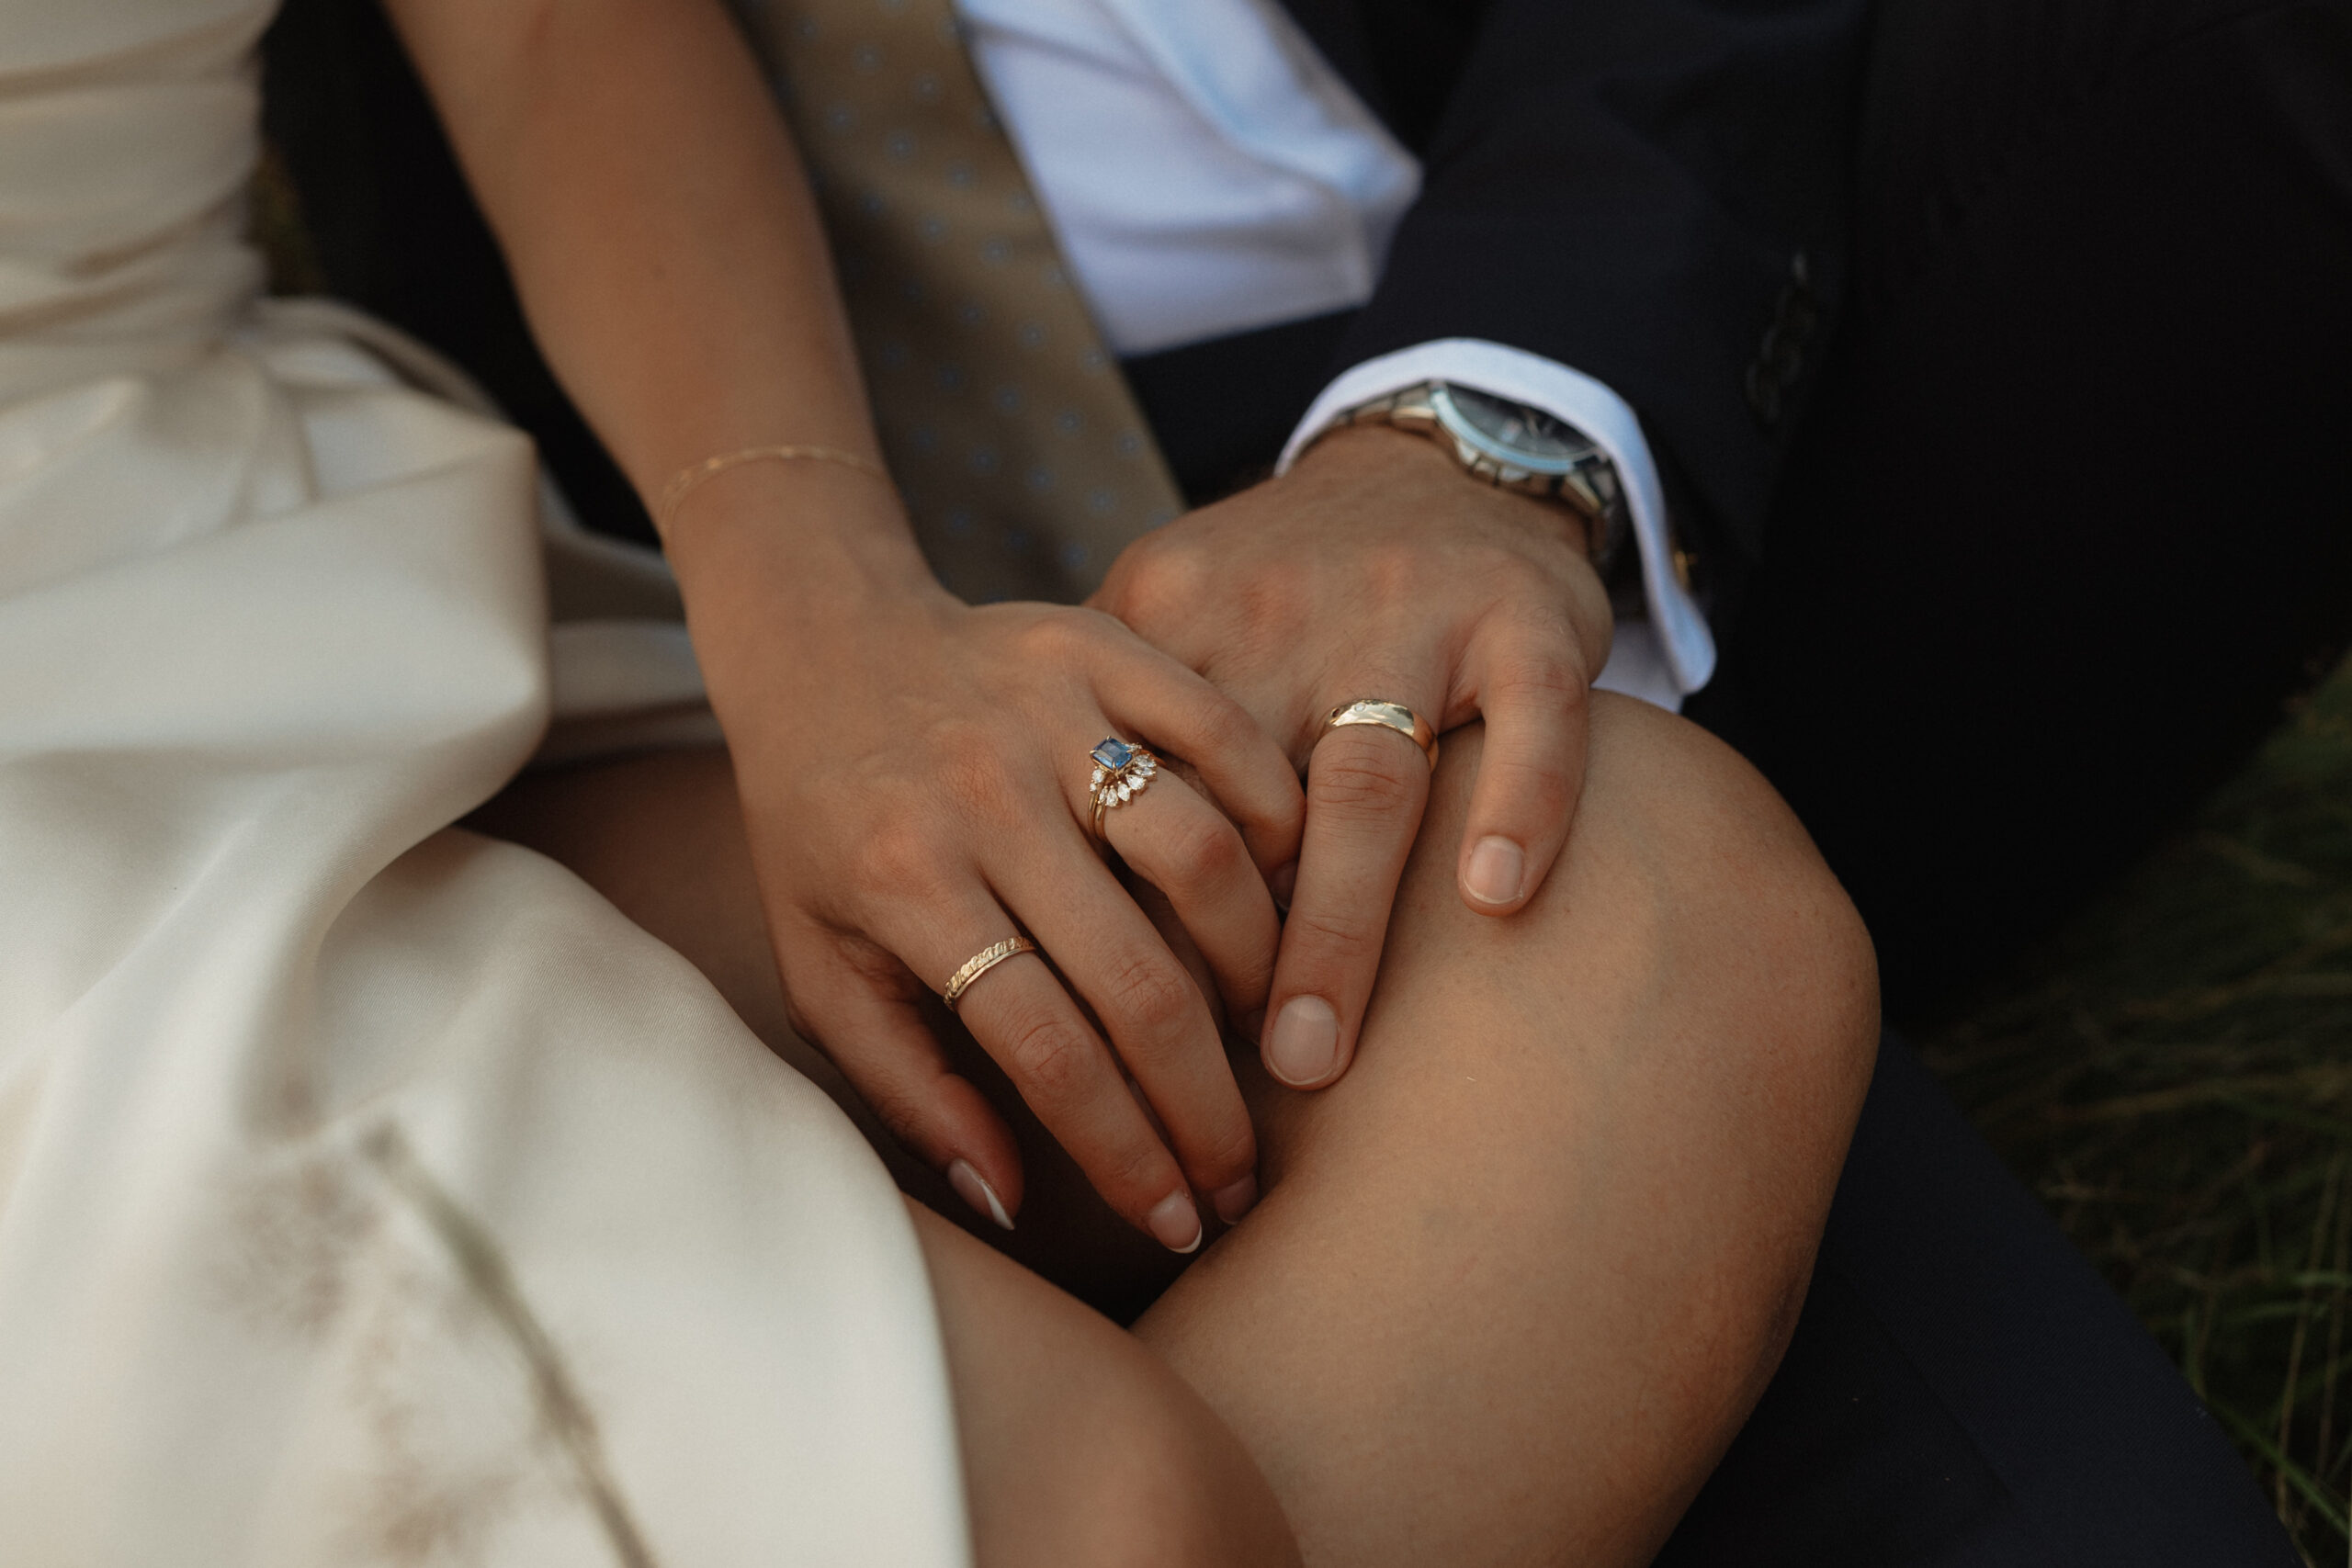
[{"xmin": 1343, "ymin": 0, "xmax": 1868, "ymax": 552}]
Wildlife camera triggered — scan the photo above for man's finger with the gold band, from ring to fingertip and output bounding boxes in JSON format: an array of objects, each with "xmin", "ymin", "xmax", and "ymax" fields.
[{"xmin": 1259, "ymin": 710, "xmax": 1430, "ymax": 1089}]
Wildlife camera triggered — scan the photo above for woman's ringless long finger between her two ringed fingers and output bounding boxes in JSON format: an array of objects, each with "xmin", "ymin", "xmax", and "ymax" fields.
[{"xmin": 974, "ymin": 829, "xmax": 1259, "ymax": 1235}]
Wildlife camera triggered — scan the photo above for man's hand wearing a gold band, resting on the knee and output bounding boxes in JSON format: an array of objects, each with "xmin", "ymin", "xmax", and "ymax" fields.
[{"xmin": 1091, "ymin": 428, "xmax": 1611, "ymax": 1089}]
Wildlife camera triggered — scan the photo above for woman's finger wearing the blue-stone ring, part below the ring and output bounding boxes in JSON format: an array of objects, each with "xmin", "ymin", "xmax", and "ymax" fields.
[{"xmin": 1099, "ymin": 769, "xmax": 1282, "ymax": 1018}]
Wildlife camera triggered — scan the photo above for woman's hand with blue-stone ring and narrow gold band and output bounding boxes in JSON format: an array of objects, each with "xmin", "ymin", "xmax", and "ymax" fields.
[{"xmin": 682, "ymin": 466, "xmax": 1303, "ymax": 1251}]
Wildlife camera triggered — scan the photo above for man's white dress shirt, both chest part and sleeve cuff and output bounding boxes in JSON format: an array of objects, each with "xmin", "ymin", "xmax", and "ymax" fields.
[{"xmin": 955, "ymin": 0, "xmax": 1714, "ymax": 707}]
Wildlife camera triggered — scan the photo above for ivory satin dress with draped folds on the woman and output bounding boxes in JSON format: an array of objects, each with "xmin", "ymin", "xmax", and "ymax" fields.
[{"xmin": 0, "ymin": 0, "xmax": 969, "ymax": 1568}]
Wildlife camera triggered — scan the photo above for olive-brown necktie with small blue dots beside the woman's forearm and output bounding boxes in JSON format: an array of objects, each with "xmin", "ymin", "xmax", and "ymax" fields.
[{"xmin": 739, "ymin": 0, "xmax": 1183, "ymax": 602}]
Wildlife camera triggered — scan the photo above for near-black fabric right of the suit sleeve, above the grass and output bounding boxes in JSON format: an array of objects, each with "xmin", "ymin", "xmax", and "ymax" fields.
[{"xmin": 1687, "ymin": 0, "xmax": 2352, "ymax": 1018}]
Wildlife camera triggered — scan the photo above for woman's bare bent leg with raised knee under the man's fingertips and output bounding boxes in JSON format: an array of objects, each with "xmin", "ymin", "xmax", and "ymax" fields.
[{"xmin": 482, "ymin": 698, "xmax": 1877, "ymax": 1563}]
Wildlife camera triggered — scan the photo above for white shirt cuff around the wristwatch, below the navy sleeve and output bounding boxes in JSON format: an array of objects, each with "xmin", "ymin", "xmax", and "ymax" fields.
[{"xmin": 1275, "ymin": 339, "xmax": 1714, "ymax": 710}]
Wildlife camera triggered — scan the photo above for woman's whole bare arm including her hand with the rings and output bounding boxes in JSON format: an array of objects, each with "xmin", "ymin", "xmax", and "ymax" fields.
[{"xmin": 390, "ymin": 0, "xmax": 1301, "ymax": 1251}]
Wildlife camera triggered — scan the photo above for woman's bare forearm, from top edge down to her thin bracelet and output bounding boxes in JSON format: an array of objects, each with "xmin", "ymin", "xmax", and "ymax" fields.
[{"xmin": 388, "ymin": 0, "xmax": 870, "ymax": 505}]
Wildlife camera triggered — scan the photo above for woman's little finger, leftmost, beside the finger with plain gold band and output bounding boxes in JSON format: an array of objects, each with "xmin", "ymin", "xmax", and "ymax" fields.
[{"xmin": 776, "ymin": 911, "xmax": 1023, "ymax": 1229}]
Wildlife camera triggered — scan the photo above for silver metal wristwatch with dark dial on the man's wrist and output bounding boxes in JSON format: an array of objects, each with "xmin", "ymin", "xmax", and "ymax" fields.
[{"xmin": 1334, "ymin": 381, "xmax": 1630, "ymax": 579}]
